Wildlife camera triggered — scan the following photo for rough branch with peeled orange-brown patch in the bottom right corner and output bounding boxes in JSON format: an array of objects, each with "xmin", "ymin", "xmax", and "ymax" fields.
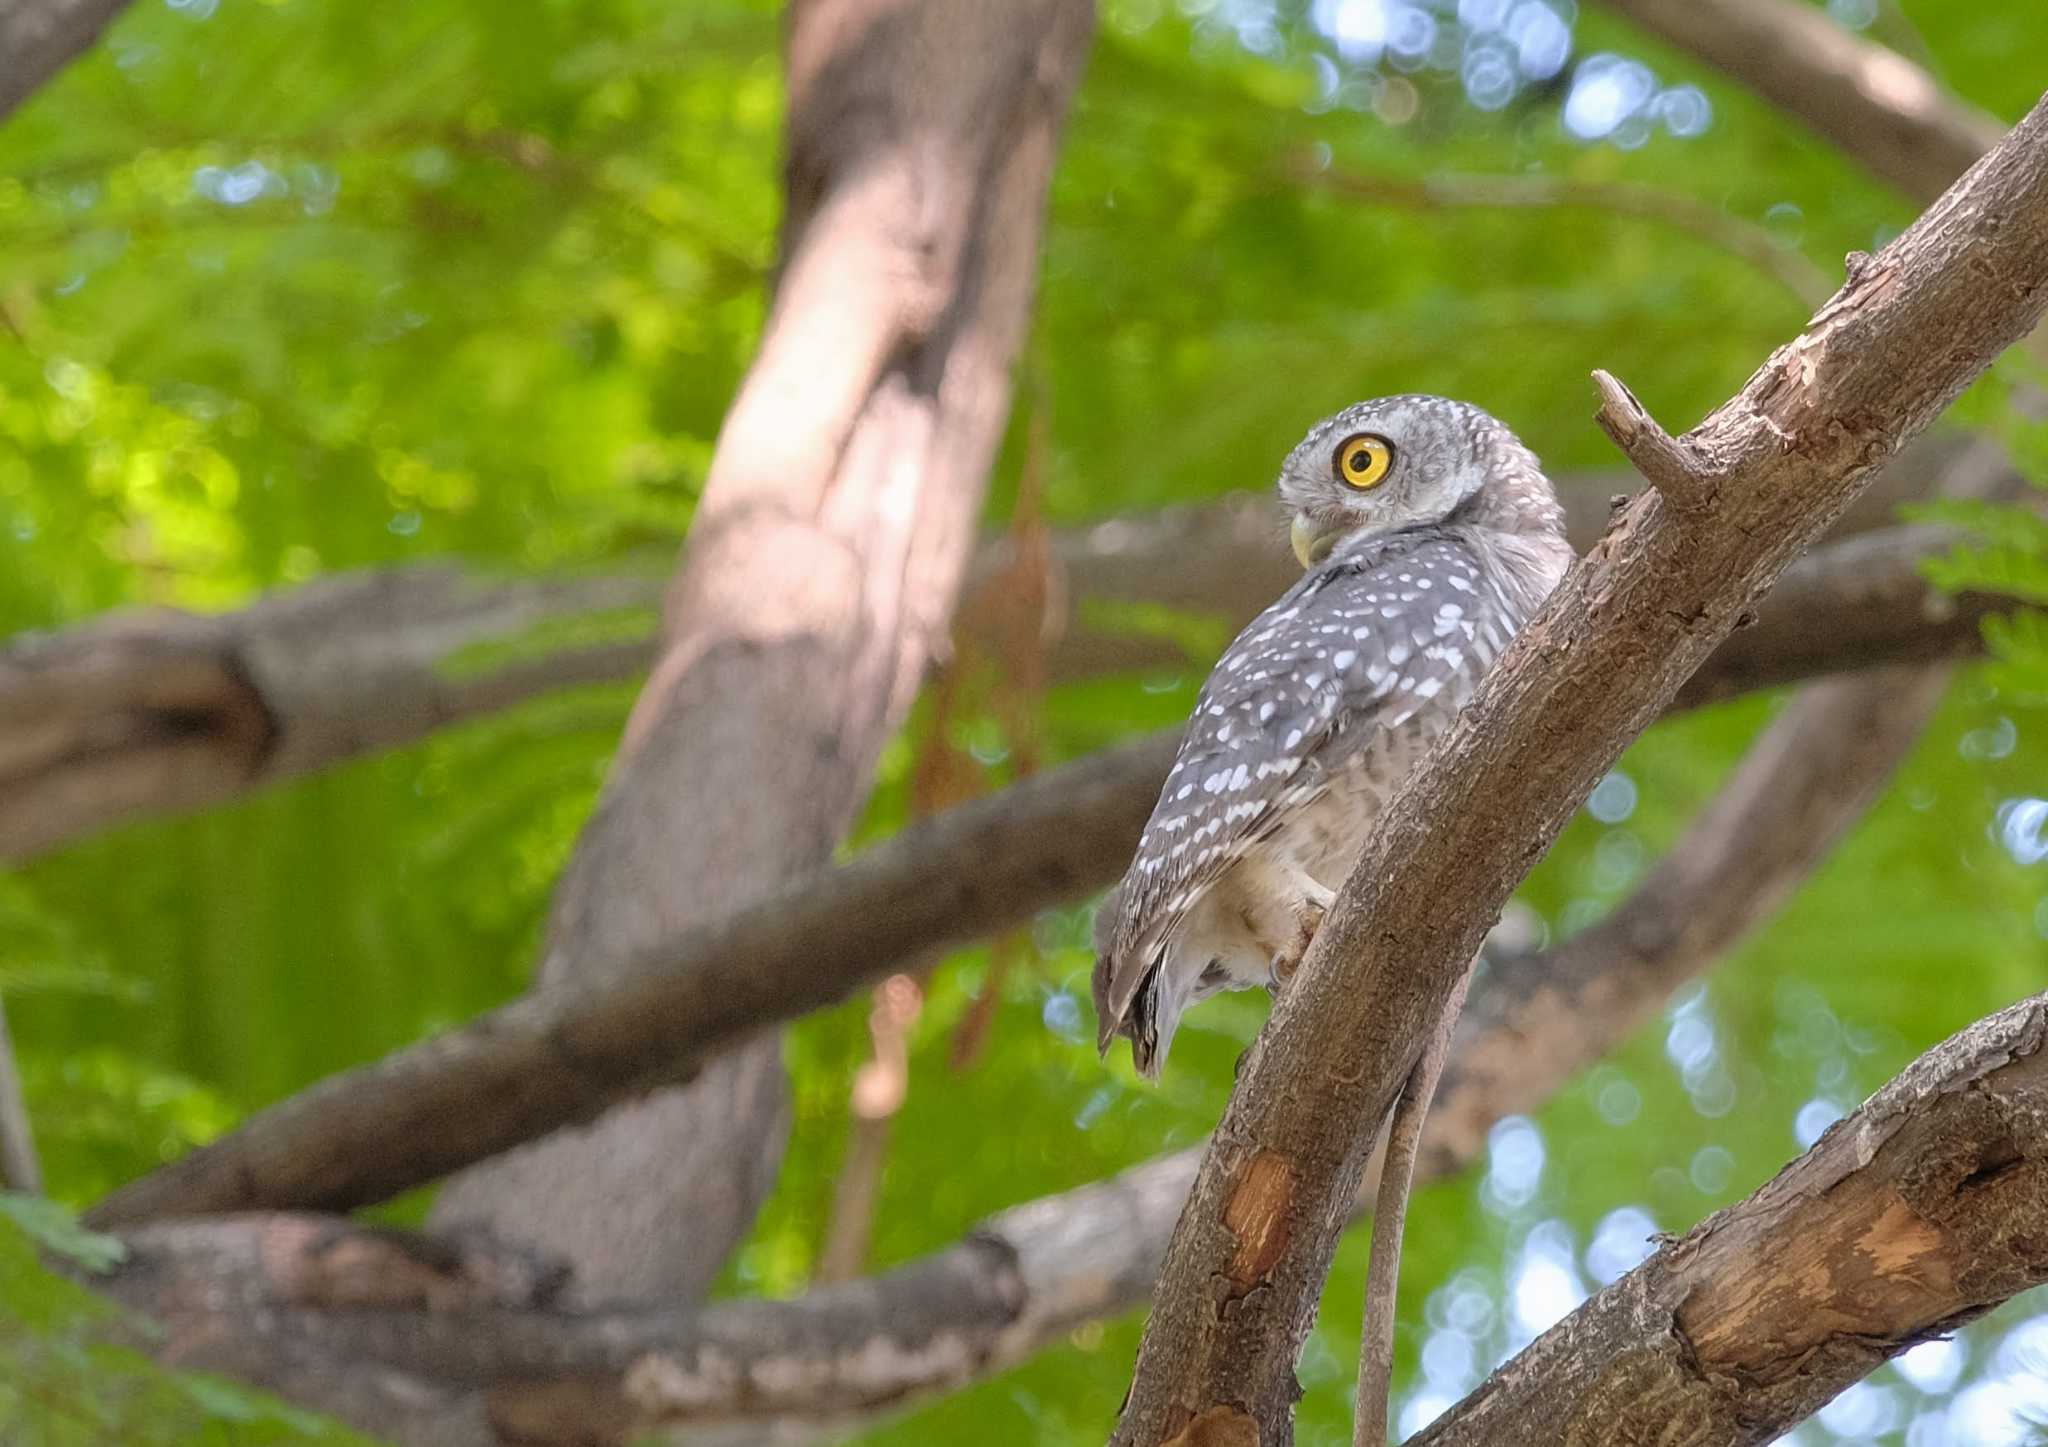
[{"xmin": 1413, "ymin": 995, "xmax": 2048, "ymax": 1447}]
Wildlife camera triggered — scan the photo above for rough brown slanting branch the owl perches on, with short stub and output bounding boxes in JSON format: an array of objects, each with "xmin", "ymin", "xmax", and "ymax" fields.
[{"xmin": 1114, "ymin": 93, "xmax": 2048, "ymax": 1443}]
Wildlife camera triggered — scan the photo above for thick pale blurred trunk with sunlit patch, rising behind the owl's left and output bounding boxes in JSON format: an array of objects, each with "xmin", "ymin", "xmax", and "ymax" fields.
[{"xmin": 434, "ymin": 0, "xmax": 1092, "ymax": 1300}]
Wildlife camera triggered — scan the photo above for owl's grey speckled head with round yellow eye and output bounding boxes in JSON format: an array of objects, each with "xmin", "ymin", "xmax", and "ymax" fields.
[{"xmin": 1280, "ymin": 393, "xmax": 1565, "ymax": 567}]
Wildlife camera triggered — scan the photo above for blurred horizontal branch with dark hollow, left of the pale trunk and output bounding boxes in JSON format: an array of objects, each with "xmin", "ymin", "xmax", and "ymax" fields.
[{"xmin": 0, "ymin": 567, "xmax": 662, "ymax": 860}]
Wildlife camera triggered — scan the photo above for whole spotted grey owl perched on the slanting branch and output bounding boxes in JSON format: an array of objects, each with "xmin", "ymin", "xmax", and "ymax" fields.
[{"xmin": 1094, "ymin": 395, "xmax": 1571, "ymax": 1077}]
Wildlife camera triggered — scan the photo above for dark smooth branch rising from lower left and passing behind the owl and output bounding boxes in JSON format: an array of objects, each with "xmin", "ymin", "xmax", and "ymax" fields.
[{"xmin": 75, "ymin": 509, "xmax": 2001, "ymax": 1222}]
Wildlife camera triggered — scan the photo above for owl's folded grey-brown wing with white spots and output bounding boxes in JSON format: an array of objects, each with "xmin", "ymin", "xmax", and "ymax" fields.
[{"xmin": 1096, "ymin": 532, "xmax": 1507, "ymax": 1044}]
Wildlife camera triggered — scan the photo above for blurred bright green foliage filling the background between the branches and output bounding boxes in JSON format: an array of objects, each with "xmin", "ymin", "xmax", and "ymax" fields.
[{"xmin": 0, "ymin": 0, "xmax": 2048, "ymax": 1443}]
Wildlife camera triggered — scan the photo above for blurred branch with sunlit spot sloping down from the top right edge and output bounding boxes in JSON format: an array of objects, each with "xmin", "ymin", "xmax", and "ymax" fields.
[{"xmin": 1606, "ymin": 0, "xmax": 1999, "ymax": 203}]
